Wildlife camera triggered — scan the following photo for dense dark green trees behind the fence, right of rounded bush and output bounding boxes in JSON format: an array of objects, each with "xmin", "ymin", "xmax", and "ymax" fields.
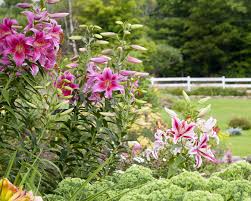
[{"xmin": 152, "ymin": 0, "xmax": 251, "ymax": 76}]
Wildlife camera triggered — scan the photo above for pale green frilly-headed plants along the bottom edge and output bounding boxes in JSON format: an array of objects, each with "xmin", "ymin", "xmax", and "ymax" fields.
[{"xmin": 45, "ymin": 162, "xmax": 251, "ymax": 201}]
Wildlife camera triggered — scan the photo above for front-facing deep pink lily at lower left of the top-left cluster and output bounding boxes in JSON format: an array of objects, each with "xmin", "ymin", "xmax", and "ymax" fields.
[{"xmin": 6, "ymin": 34, "xmax": 30, "ymax": 66}]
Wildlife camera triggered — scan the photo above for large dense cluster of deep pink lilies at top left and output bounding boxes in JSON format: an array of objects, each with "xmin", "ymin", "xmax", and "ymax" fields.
[{"xmin": 0, "ymin": 8, "xmax": 63, "ymax": 75}]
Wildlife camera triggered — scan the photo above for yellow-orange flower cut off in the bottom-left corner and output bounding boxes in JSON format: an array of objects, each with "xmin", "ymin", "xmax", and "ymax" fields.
[{"xmin": 0, "ymin": 178, "xmax": 43, "ymax": 201}]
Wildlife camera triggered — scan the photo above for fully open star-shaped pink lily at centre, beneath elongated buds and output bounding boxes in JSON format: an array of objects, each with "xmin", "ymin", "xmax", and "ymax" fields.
[{"xmin": 93, "ymin": 68, "xmax": 124, "ymax": 98}]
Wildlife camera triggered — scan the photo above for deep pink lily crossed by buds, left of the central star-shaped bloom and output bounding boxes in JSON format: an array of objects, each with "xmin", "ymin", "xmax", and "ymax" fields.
[{"xmin": 54, "ymin": 71, "xmax": 79, "ymax": 96}]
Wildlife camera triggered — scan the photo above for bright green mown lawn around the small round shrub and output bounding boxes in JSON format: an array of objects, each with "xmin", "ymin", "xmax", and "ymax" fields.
[{"xmin": 209, "ymin": 98, "xmax": 251, "ymax": 156}]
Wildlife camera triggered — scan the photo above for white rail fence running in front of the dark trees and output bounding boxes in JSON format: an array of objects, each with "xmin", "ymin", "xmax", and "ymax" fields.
[{"xmin": 151, "ymin": 76, "xmax": 251, "ymax": 91}]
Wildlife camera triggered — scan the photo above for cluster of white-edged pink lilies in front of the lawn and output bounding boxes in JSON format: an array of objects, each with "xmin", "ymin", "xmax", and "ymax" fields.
[{"xmin": 145, "ymin": 117, "xmax": 217, "ymax": 168}]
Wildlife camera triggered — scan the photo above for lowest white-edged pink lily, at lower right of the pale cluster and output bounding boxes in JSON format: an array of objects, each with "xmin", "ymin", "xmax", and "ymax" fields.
[{"xmin": 189, "ymin": 134, "xmax": 216, "ymax": 168}]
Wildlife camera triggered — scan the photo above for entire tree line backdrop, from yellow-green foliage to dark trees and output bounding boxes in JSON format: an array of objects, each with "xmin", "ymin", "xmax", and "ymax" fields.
[{"xmin": 0, "ymin": 0, "xmax": 251, "ymax": 77}]
